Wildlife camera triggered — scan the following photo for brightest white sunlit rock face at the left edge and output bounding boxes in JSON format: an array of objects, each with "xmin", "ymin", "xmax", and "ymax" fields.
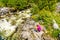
[{"xmin": 0, "ymin": 19, "xmax": 16, "ymax": 37}]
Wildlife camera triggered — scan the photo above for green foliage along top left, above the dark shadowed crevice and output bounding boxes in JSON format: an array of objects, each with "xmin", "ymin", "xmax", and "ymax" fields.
[{"xmin": 0, "ymin": 0, "xmax": 29, "ymax": 9}]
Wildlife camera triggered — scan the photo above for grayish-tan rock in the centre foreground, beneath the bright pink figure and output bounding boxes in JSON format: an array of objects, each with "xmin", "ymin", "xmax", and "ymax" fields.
[{"xmin": 21, "ymin": 18, "xmax": 43, "ymax": 40}]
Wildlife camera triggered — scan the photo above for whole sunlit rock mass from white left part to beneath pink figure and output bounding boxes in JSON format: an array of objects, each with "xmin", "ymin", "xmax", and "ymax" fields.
[{"xmin": 0, "ymin": 9, "xmax": 44, "ymax": 40}]
